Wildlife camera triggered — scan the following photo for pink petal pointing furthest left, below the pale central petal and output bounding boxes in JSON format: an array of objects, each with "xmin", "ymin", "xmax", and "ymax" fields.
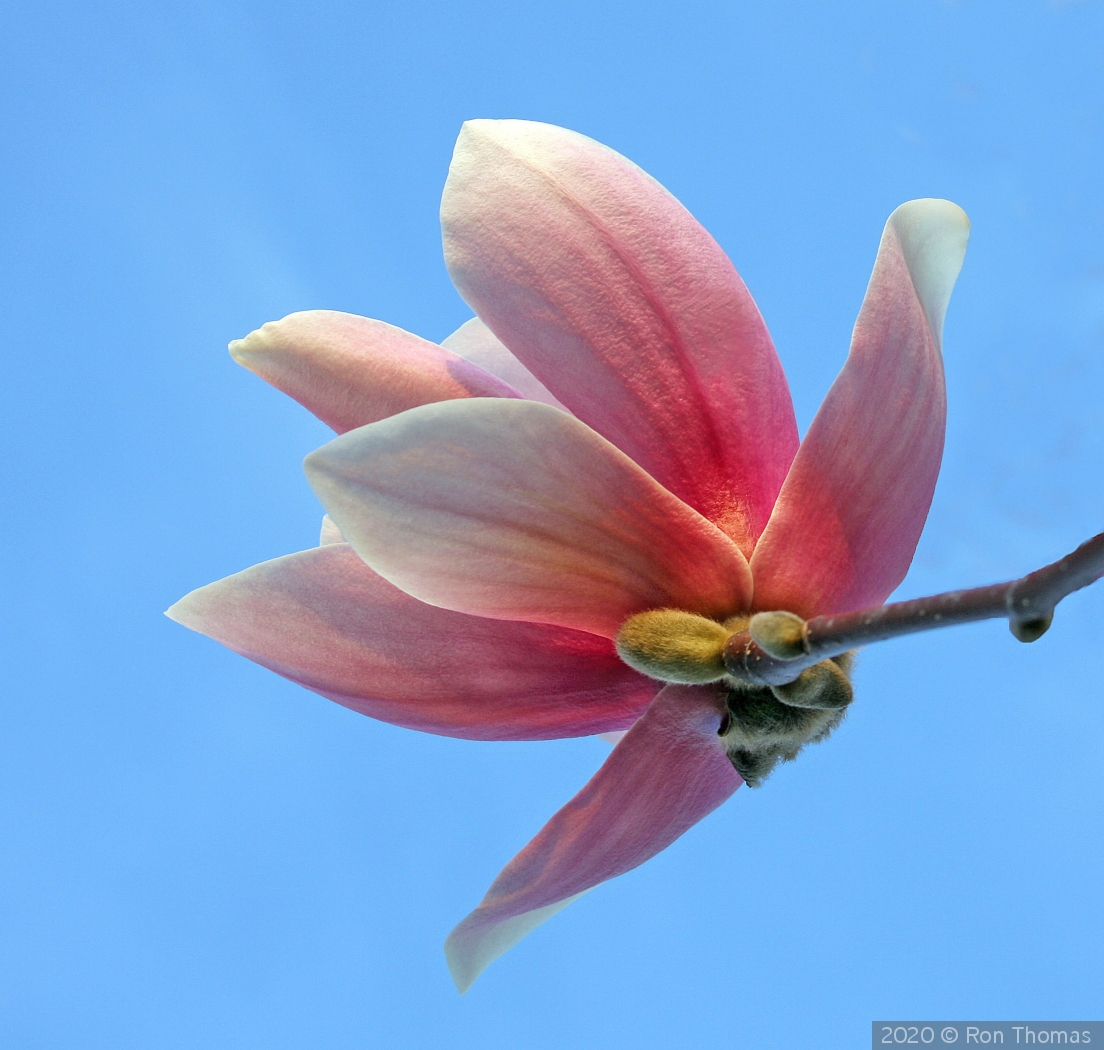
[{"xmin": 167, "ymin": 543, "xmax": 660, "ymax": 740}]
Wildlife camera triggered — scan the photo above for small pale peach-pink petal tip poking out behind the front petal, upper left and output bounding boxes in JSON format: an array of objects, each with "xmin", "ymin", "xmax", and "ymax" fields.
[{"xmin": 230, "ymin": 310, "xmax": 520, "ymax": 434}]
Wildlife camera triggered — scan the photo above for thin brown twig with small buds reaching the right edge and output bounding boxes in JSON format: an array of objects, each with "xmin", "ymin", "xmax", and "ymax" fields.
[{"xmin": 724, "ymin": 532, "xmax": 1104, "ymax": 686}]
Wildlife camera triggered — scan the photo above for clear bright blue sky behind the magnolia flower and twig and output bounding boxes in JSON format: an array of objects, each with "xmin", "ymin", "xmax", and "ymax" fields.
[{"xmin": 0, "ymin": 0, "xmax": 1104, "ymax": 1050}]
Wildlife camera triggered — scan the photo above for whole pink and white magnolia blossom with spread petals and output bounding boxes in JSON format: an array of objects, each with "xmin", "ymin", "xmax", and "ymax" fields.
[{"xmin": 169, "ymin": 120, "xmax": 968, "ymax": 990}]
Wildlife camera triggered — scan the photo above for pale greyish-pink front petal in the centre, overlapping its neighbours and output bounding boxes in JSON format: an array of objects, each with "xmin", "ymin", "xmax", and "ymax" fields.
[{"xmin": 306, "ymin": 399, "xmax": 751, "ymax": 638}]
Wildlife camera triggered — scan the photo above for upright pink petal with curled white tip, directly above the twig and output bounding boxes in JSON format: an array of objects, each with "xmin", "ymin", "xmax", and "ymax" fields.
[{"xmin": 752, "ymin": 200, "xmax": 969, "ymax": 616}]
